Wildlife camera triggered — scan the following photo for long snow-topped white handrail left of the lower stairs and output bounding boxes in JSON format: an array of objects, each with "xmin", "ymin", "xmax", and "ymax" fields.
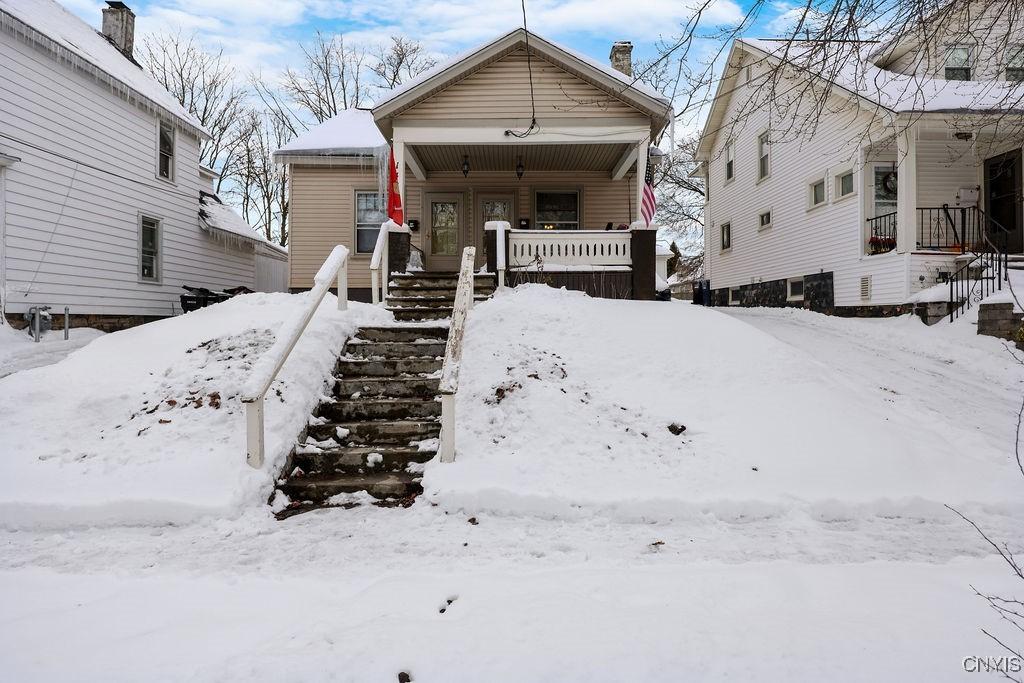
[{"xmin": 242, "ymin": 245, "xmax": 348, "ymax": 468}]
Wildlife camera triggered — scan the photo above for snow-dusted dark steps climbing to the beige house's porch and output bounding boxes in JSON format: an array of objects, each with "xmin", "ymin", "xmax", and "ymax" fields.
[{"xmin": 278, "ymin": 272, "xmax": 496, "ymax": 517}]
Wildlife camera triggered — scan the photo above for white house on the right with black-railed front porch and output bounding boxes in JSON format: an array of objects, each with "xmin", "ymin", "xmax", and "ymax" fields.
[{"xmin": 697, "ymin": 2, "xmax": 1024, "ymax": 315}]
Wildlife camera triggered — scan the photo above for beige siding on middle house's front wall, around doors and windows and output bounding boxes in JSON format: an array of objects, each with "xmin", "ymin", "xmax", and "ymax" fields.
[{"xmin": 289, "ymin": 166, "xmax": 635, "ymax": 288}]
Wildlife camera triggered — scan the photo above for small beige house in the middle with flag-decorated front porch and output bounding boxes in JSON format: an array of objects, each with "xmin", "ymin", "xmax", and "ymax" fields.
[{"xmin": 275, "ymin": 29, "xmax": 672, "ymax": 300}]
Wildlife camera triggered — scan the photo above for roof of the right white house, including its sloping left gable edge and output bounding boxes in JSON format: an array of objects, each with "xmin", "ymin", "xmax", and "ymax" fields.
[{"xmin": 697, "ymin": 38, "xmax": 1024, "ymax": 159}]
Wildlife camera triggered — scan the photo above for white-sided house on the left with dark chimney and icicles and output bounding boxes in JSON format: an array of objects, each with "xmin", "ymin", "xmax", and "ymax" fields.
[{"xmin": 0, "ymin": 0, "xmax": 287, "ymax": 330}]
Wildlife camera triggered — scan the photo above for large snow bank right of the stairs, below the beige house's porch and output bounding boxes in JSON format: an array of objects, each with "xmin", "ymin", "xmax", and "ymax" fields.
[{"xmin": 424, "ymin": 286, "xmax": 1022, "ymax": 521}]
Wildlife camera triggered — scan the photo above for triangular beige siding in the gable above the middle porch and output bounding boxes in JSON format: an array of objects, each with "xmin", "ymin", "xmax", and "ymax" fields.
[{"xmin": 401, "ymin": 50, "xmax": 647, "ymax": 121}]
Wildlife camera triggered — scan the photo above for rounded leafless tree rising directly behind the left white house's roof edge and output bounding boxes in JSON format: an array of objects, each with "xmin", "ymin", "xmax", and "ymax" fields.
[{"xmin": 138, "ymin": 33, "xmax": 249, "ymax": 191}]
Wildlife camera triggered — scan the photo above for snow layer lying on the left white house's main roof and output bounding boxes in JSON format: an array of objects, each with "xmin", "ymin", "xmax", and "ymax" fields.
[{"xmin": 0, "ymin": 0, "xmax": 206, "ymax": 133}]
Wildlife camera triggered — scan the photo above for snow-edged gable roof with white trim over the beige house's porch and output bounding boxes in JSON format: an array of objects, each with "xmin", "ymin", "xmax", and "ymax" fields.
[{"xmin": 373, "ymin": 29, "xmax": 672, "ymax": 134}]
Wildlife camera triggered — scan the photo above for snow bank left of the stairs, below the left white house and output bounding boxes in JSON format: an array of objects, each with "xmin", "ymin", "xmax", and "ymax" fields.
[{"xmin": 0, "ymin": 294, "xmax": 390, "ymax": 527}]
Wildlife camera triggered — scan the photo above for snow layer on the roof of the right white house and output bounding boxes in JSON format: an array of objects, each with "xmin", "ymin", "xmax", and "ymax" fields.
[{"xmin": 738, "ymin": 38, "xmax": 1024, "ymax": 113}]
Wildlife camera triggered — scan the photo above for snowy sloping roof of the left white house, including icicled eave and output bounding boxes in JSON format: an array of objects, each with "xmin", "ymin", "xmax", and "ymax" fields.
[{"xmin": 0, "ymin": 0, "xmax": 209, "ymax": 137}]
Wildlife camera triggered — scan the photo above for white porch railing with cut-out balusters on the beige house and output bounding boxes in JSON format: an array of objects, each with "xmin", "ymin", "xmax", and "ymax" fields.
[{"xmin": 499, "ymin": 230, "xmax": 633, "ymax": 269}]
